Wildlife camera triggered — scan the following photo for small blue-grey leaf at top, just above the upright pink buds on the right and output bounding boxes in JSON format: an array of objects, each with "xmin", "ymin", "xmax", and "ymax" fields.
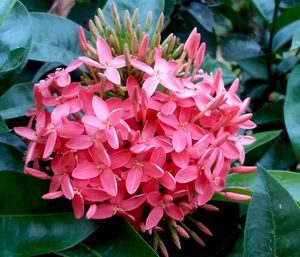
[{"xmin": 187, "ymin": 2, "xmax": 214, "ymax": 32}]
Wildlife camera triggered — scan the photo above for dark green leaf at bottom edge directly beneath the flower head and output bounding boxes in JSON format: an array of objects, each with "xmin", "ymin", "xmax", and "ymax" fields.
[{"xmin": 59, "ymin": 220, "xmax": 158, "ymax": 257}]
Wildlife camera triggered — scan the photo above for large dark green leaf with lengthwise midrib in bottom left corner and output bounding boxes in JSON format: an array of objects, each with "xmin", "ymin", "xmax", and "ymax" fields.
[{"xmin": 0, "ymin": 171, "xmax": 97, "ymax": 257}]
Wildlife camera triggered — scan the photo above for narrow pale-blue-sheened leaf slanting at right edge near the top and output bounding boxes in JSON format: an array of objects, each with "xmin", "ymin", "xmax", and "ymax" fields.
[{"xmin": 272, "ymin": 20, "xmax": 300, "ymax": 52}]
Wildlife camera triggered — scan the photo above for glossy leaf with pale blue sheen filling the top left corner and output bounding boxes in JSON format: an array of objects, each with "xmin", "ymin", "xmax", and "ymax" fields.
[{"xmin": 0, "ymin": 1, "xmax": 31, "ymax": 92}]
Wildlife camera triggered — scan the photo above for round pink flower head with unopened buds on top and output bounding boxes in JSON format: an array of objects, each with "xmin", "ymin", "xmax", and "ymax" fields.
[{"xmin": 14, "ymin": 5, "xmax": 255, "ymax": 256}]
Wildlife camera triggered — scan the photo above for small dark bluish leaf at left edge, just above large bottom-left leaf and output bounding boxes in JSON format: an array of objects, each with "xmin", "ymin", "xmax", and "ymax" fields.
[{"xmin": 0, "ymin": 143, "xmax": 24, "ymax": 171}]
